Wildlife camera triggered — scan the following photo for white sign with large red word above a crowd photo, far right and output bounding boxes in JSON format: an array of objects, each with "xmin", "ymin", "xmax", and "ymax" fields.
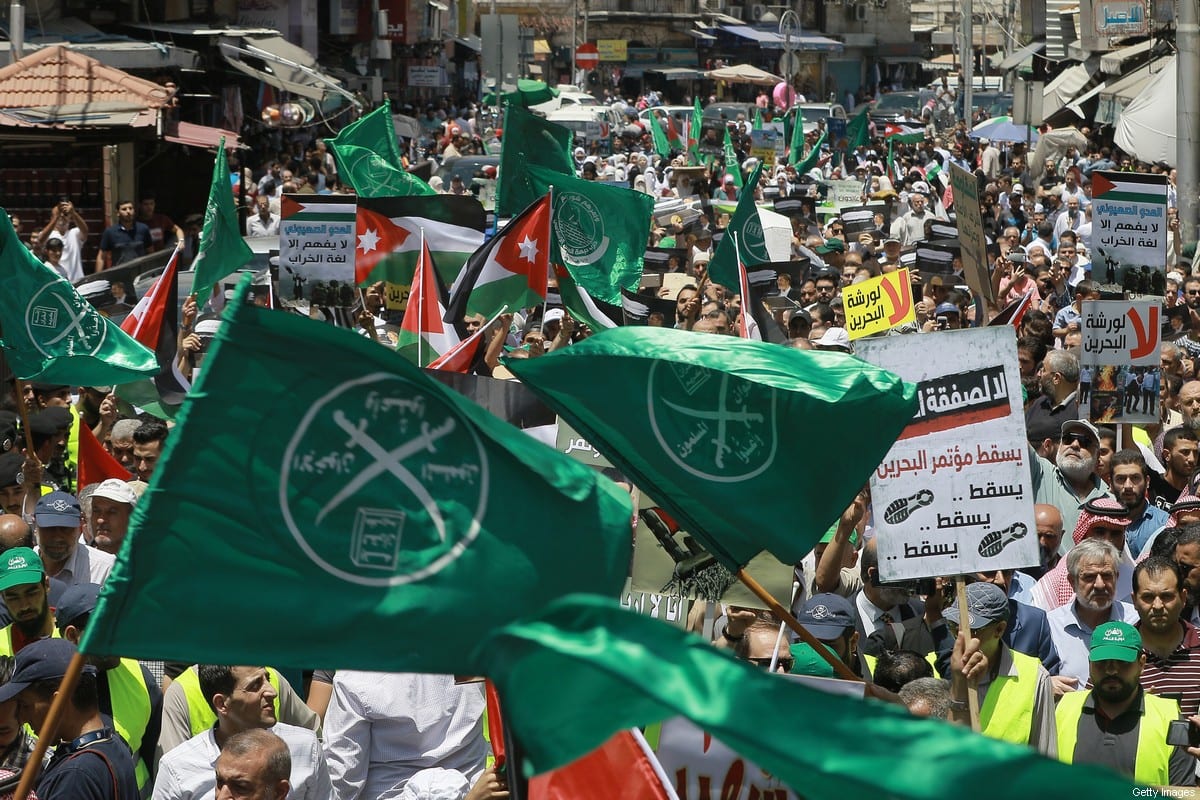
[{"xmin": 1079, "ymin": 300, "xmax": 1162, "ymax": 423}]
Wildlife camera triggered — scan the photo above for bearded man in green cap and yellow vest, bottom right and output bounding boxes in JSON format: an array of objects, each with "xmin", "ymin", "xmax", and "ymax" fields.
[{"xmin": 1056, "ymin": 621, "xmax": 1195, "ymax": 786}]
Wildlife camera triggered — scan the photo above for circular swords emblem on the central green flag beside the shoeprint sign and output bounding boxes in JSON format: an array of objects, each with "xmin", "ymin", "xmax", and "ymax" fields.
[{"xmin": 646, "ymin": 361, "xmax": 779, "ymax": 483}]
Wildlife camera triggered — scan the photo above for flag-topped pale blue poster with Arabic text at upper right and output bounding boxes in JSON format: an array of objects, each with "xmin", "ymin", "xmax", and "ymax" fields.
[{"xmin": 1090, "ymin": 170, "xmax": 1166, "ymax": 295}]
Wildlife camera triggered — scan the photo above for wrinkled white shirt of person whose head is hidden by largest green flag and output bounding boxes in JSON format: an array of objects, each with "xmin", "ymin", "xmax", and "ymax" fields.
[{"xmin": 325, "ymin": 670, "xmax": 487, "ymax": 800}]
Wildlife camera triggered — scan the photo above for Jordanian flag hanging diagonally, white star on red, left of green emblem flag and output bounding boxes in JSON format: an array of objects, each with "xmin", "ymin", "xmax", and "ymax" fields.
[{"xmin": 445, "ymin": 194, "xmax": 551, "ymax": 325}]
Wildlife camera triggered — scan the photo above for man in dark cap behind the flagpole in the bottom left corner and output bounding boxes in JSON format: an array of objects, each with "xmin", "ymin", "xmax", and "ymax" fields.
[{"xmin": 0, "ymin": 639, "xmax": 138, "ymax": 800}]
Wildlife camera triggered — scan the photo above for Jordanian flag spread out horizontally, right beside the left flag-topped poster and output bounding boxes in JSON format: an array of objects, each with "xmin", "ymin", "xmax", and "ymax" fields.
[{"xmin": 354, "ymin": 194, "xmax": 486, "ymax": 285}]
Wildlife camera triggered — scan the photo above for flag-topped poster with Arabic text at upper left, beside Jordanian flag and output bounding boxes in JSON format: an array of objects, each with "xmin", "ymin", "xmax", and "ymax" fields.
[{"xmin": 280, "ymin": 194, "xmax": 358, "ymax": 319}]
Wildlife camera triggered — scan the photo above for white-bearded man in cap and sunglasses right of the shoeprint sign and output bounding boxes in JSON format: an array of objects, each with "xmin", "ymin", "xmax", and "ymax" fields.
[{"xmin": 1030, "ymin": 420, "xmax": 1112, "ymax": 530}]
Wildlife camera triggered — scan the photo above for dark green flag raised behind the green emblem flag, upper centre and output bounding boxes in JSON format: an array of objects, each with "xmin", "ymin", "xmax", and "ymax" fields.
[{"xmin": 496, "ymin": 103, "xmax": 575, "ymax": 218}]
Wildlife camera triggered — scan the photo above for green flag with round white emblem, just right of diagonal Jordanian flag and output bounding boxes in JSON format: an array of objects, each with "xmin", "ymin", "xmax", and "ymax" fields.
[{"xmin": 529, "ymin": 166, "xmax": 654, "ymax": 306}]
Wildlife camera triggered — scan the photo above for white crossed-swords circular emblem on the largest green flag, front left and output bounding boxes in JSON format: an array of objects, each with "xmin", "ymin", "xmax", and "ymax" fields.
[{"xmin": 280, "ymin": 372, "xmax": 488, "ymax": 587}]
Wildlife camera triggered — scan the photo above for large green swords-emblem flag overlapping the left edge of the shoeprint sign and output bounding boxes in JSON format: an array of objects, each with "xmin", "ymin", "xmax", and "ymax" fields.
[{"xmin": 506, "ymin": 326, "xmax": 917, "ymax": 571}]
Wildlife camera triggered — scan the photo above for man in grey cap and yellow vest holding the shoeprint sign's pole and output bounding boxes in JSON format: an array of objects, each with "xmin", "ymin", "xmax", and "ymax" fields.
[{"xmin": 942, "ymin": 582, "xmax": 1056, "ymax": 758}]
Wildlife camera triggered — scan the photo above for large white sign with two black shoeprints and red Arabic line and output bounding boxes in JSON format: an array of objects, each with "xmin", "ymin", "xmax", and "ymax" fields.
[{"xmin": 856, "ymin": 326, "xmax": 1038, "ymax": 581}]
